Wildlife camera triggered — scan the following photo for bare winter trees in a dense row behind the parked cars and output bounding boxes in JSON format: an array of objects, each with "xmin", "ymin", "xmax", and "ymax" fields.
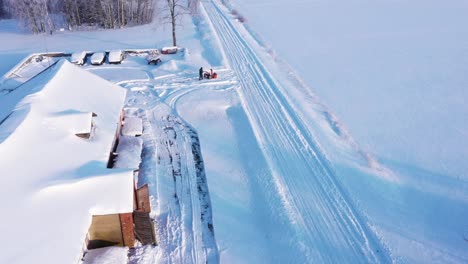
[{"xmin": 0, "ymin": 0, "xmax": 157, "ymax": 33}]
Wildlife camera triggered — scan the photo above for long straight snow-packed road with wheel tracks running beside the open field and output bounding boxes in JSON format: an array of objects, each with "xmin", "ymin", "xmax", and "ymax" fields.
[{"xmin": 203, "ymin": 1, "xmax": 390, "ymax": 263}]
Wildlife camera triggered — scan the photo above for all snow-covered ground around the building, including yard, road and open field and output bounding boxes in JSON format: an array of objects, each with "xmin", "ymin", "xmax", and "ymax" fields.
[{"xmin": 0, "ymin": 0, "xmax": 468, "ymax": 263}]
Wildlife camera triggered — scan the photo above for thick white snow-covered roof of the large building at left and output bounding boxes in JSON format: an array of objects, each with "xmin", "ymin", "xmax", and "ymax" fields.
[{"xmin": 0, "ymin": 60, "xmax": 133, "ymax": 264}]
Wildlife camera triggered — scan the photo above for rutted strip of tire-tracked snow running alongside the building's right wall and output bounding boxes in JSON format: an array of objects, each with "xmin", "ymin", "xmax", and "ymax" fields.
[{"xmin": 126, "ymin": 83, "xmax": 218, "ymax": 263}]
